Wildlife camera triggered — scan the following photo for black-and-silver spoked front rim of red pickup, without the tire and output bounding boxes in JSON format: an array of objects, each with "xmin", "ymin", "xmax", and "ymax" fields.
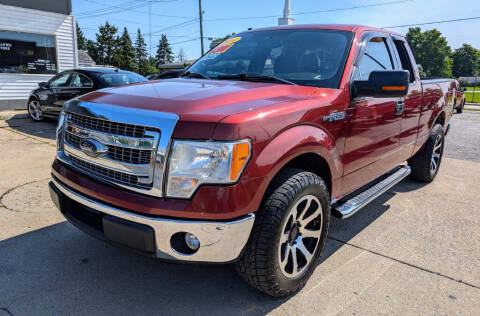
[{"xmin": 277, "ymin": 195, "xmax": 323, "ymax": 278}]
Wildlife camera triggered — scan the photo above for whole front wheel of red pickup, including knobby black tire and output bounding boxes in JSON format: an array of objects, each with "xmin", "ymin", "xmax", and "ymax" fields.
[{"xmin": 236, "ymin": 169, "xmax": 330, "ymax": 297}]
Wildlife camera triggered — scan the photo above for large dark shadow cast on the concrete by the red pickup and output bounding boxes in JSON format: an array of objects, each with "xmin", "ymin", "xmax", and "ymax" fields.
[{"xmin": 0, "ymin": 181, "xmax": 424, "ymax": 315}]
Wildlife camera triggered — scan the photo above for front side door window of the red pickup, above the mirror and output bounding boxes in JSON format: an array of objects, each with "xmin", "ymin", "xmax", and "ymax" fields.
[{"xmin": 355, "ymin": 37, "xmax": 394, "ymax": 80}]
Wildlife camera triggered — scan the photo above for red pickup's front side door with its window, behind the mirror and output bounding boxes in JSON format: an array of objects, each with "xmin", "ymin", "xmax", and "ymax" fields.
[{"xmin": 342, "ymin": 33, "xmax": 401, "ymax": 194}]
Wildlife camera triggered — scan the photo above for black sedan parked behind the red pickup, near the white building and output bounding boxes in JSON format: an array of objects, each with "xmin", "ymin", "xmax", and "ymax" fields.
[{"xmin": 28, "ymin": 68, "xmax": 147, "ymax": 121}]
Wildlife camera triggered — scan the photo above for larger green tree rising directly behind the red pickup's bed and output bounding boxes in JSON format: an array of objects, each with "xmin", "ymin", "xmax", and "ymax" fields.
[{"xmin": 406, "ymin": 27, "xmax": 452, "ymax": 77}]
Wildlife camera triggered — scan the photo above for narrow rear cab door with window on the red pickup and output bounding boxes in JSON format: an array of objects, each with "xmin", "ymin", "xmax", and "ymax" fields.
[{"xmin": 392, "ymin": 37, "xmax": 423, "ymax": 160}]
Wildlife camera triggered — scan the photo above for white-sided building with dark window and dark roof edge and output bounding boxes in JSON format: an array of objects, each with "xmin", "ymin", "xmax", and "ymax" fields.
[{"xmin": 0, "ymin": 0, "xmax": 78, "ymax": 110}]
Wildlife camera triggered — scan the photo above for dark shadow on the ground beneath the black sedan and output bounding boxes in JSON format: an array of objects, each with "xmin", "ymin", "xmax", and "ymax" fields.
[{"xmin": 5, "ymin": 115, "xmax": 57, "ymax": 140}]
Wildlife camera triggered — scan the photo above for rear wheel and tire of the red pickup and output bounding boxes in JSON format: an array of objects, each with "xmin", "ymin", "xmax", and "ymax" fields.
[{"xmin": 408, "ymin": 124, "xmax": 445, "ymax": 182}]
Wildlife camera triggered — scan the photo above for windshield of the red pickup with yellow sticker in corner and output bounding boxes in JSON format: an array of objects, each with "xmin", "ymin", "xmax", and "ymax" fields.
[{"xmin": 188, "ymin": 29, "xmax": 352, "ymax": 88}]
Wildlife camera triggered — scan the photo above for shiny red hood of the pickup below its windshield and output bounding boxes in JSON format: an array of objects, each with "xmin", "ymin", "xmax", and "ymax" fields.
[{"xmin": 80, "ymin": 78, "xmax": 330, "ymax": 121}]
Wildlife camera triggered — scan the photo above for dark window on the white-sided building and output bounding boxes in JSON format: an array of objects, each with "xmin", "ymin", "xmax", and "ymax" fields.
[{"xmin": 0, "ymin": 30, "xmax": 57, "ymax": 74}]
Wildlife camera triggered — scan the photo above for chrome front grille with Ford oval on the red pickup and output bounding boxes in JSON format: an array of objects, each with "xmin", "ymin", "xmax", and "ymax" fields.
[{"xmin": 57, "ymin": 100, "xmax": 178, "ymax": 196}]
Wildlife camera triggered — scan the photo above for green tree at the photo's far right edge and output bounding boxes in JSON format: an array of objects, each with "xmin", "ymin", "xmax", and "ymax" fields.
[{"xmin": 452, "ymin": 44, "xmax": 480, "ymax": 78}]
